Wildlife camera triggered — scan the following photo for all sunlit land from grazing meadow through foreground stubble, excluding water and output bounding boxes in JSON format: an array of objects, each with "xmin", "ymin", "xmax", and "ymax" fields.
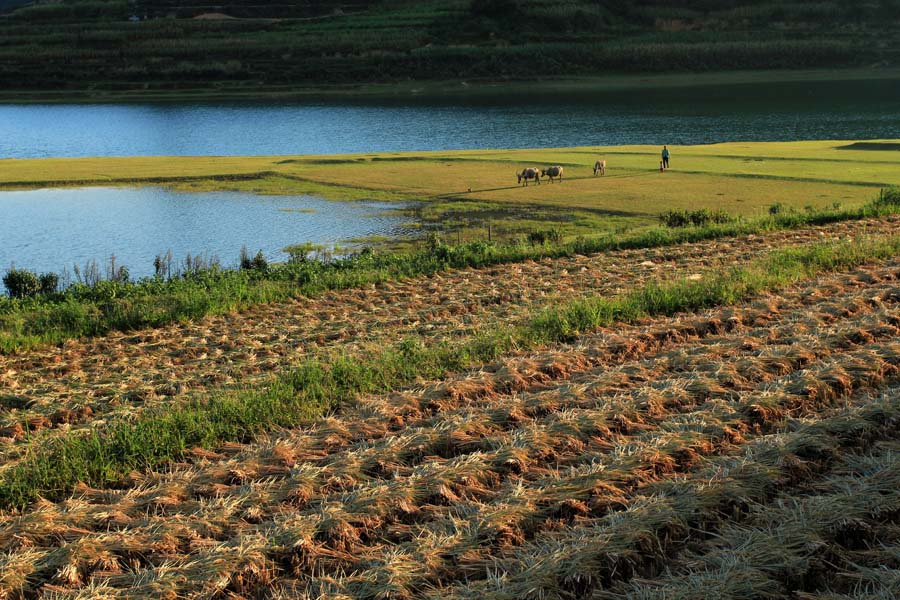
[{"xmin": 0, "ymin": 142, "xmax": 900, "ymax": 600}]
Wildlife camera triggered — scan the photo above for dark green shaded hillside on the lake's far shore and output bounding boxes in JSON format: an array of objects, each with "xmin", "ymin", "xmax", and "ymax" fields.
[{"xmin": 0, "ymin": 0, "xmax": 900, "ymax": 99}]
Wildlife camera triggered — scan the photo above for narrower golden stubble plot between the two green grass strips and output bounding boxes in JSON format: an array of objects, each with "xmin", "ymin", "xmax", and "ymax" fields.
[{"xmin": 0, "ymin": 217, "xmax": 900, "ymax": 460}]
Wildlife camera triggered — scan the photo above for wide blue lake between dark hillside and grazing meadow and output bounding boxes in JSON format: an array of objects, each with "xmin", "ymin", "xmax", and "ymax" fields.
[{"xmin": 0, "ymin": 80, "xmax": 900, "ymax": 158}]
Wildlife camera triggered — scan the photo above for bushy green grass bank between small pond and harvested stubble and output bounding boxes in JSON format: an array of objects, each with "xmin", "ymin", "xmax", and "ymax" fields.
[{"xmin": 0, "ymin": 188, "xmax": 900, "ymax": 354}]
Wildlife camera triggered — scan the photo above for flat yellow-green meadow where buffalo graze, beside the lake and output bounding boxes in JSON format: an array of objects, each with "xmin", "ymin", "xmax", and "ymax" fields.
[{"xmin": 0, "ymin": 140, "xmax": 900, "ymax": 242}]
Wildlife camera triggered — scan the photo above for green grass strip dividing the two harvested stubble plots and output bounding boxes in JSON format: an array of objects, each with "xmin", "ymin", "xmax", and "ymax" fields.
[{"xmin": 0, "ymin": 236, "xmax": 900, "ymax": 508}]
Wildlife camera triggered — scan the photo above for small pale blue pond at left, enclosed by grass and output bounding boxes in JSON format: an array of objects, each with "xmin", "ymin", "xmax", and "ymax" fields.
[{"xmin": 0, "ymin": 187, "xmax": 404, "ymax": 278}]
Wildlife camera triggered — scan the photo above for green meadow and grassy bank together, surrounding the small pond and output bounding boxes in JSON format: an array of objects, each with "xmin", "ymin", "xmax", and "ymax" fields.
[{"xmin": 0, "ymin": 141, "xmax": 900, "ymax": 351}]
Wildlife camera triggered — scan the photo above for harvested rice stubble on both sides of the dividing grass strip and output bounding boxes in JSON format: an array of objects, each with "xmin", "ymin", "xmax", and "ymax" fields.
[{"xmin": 0, "ymin": 217, "xmax": 900, "ymax": 600}]
